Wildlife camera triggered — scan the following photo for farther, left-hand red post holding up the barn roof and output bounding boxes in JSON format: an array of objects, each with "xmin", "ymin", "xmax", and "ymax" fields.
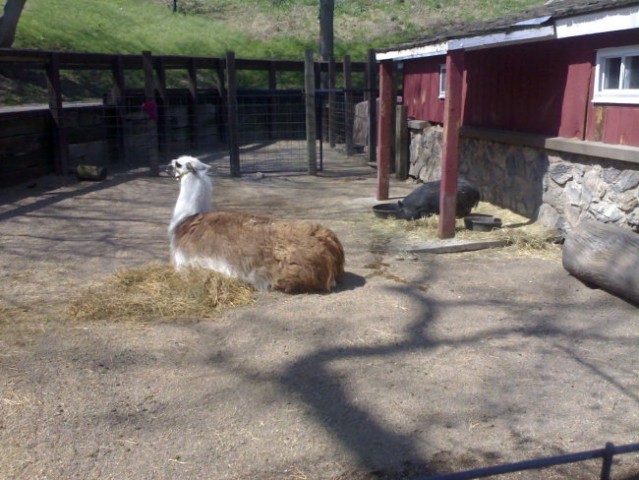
[{"xmin": 377, "ymin": 61, "xmax": 395, "ymax": 200}]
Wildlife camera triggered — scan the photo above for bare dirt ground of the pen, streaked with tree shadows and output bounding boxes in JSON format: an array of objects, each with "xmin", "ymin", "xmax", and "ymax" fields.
[{"xmin": 0, "ymin": 153, "xmax": 639, "ymax": 480}]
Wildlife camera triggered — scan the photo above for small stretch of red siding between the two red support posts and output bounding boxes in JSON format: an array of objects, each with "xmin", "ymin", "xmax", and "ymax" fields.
[{"xmin": 404, "ymin": 56, "xmax": 446, "ymax": 123}]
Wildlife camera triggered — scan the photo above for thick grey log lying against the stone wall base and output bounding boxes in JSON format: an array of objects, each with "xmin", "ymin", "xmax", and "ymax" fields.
[{"xmin": 562, "ymin": 220, "xmax": 639, "ymax": 305}]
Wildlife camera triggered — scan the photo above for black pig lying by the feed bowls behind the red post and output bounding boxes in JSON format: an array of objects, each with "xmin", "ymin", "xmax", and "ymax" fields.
[{"xmin": 397, "ymin": 178, "xmax": 480, "ymax": 220}]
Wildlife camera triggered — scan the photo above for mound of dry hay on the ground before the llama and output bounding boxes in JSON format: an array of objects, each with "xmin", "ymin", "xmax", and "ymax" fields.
[{"xmin": 67, "ymin": 265, "xmax": 253, "ymax": 320}]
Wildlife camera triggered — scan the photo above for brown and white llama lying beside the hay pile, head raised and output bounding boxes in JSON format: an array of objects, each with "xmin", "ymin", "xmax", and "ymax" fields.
[{"xmin": 167, "ymin": 156, "xmax": 344, "ymax": 293}]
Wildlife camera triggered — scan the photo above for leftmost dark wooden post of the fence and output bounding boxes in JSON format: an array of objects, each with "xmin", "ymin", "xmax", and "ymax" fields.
[{"xmin": 47, "ymin": 53, "xmax": 69, "ymax": 175}]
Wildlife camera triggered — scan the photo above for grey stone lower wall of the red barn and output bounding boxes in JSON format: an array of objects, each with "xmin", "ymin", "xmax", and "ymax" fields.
[{"xmin": 410, "ymin": 124, "xmax": 639, "ymax": 232}]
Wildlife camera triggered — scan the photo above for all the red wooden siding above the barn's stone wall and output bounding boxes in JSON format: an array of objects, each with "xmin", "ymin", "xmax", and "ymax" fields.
[{"xmin": 404, "ymin": 30, "xmax": 639, "ymax": 146}]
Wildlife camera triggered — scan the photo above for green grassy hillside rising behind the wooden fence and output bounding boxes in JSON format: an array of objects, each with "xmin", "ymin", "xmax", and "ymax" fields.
[{"xmin": 14, "ymin": 0, "xmax": 544, "ymax": 60}]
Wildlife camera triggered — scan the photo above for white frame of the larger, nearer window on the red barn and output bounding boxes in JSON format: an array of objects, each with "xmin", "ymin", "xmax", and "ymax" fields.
[{"xmin": 592, "ymin": 45, "xmax": 639, "ymax": 105}]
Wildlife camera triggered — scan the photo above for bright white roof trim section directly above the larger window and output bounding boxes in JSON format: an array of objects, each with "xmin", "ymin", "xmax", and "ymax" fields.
[{"xmin": 555, "ymin": 6, "xmax": 639, "ymax": 38}]
